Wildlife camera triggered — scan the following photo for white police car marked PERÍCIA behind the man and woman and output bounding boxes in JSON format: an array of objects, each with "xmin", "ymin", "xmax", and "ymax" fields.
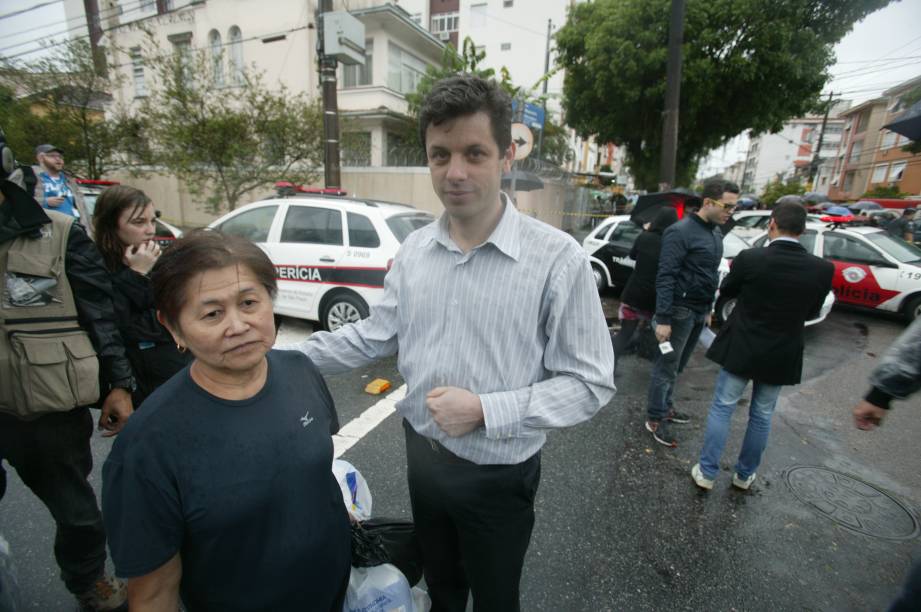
[{"xmin": 208, "ymin": 188, "xmax": 435, "ymax": 330}]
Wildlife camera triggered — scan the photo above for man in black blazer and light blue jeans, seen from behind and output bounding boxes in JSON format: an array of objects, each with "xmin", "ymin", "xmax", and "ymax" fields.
[{"xmin": 691, "ymin": 197, "xmax": 835, "ymax": 489}]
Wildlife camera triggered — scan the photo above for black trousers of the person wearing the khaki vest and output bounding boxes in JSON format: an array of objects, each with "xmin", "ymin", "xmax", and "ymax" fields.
[{"xmin": 0, "ymin": 408, "xmax": 106, "ymax": 595}]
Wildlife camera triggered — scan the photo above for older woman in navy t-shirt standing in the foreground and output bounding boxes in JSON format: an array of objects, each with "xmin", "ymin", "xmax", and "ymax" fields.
[{"xmin": 102, "ymin": 232, "xmax": 350, "ymax": 612}]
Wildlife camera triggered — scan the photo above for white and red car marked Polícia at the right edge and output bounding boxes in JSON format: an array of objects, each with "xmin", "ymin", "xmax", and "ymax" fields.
[{"xmin": 752, "ymin": 223, "xmax": 921, "ymax": 321}]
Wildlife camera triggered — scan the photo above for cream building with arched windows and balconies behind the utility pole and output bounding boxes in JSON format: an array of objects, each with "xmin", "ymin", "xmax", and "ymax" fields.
[{"xmin": 71, "ymin": 0, "xmax": 445, "ymax": 166}]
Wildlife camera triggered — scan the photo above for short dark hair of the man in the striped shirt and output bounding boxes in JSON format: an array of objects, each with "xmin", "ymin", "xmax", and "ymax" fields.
[{"xmin": 419, "ymin": 72, "xmax": 512, "ymax": 157}]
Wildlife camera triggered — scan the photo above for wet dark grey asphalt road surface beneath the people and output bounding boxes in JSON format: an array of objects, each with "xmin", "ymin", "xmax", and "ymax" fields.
[{"xmin": 0, "ymin": 304, "xmax": 921, "ymax": 612}]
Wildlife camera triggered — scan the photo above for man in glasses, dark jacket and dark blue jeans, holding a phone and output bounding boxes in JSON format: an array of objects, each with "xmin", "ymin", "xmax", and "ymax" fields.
[{"xmin": 646, "ymin": 179, "xmax": 739, "ymax": 448}]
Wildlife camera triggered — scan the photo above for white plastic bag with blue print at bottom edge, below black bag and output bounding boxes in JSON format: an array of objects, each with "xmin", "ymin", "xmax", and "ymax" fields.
[{"xmin": 343, "ymin": 563, "xmax": 422, "ymax": 612}]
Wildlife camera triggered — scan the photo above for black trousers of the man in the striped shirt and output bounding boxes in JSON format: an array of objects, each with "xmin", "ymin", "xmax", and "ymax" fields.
[{"xmin": 403, "ymin": 420, "xmax": 540, "ymax": 612}]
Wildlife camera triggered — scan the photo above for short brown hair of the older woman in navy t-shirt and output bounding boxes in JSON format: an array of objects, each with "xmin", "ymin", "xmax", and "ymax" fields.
[{"xmin": 150, "ymin": 229, "xmax": 278, "ymax": 328}]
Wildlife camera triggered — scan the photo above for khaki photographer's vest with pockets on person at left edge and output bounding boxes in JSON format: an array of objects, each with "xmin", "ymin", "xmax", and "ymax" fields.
[{"xmin": 0, "ymin": 211, "xmax": 99, "ymax": 420}]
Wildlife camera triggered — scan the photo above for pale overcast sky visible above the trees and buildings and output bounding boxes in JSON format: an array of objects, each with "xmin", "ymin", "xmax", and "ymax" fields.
[{"xmin": 0, "ymin": 0, "xmax": 921, "ymax": 175}]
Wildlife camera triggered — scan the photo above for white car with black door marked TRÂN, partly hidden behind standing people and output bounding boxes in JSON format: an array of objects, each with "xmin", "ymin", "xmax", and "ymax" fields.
[{"xmin": 582, "ymin": 215, "xmax": 748, "ymax": 291}]
